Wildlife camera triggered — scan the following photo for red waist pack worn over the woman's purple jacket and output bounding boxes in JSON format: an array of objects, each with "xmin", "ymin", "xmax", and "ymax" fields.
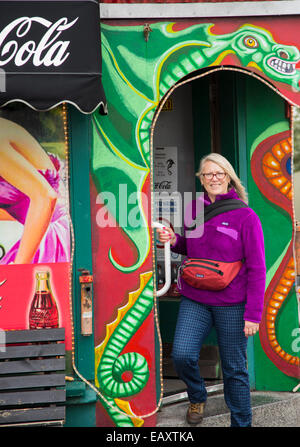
[{"xmin": 178, "ymin": 258, "xmax": 243, "ymax": 290}]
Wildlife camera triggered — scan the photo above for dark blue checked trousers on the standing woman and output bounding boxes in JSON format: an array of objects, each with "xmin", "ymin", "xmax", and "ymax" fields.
[{"xmin": 172, "ymin": 297, "xmax": 252, "ymax": 427}]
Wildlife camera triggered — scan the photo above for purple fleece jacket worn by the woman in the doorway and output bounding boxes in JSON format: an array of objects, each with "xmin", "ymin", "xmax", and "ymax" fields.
[{"xmin": 171, "ymin": 188, "xmax": 266, "ymax": 323}]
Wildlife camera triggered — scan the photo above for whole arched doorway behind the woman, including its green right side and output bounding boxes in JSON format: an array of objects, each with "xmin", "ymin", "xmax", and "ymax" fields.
[{"xmin": 153, "ymin": 70, "xmax": 290, "ymax": 399}]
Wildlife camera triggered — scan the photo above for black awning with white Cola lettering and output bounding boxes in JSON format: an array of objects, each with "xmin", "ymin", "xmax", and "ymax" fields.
[{"xmin": 0, "ymin": 0, "xmax": 106, "ymax": 113}]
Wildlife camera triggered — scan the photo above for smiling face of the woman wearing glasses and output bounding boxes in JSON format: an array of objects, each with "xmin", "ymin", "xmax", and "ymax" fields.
[{"xmin": 200, "ymin": 161, "xmax": 230, "ymax": 202}]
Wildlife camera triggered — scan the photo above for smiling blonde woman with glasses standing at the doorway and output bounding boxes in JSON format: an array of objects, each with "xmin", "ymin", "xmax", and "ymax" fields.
[{"xmin": 157, "ymin": 153, "xmax": 266, "ymax": 426}]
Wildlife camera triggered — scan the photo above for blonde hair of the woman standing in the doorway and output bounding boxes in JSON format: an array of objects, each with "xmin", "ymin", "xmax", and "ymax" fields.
[{"xmin": 196, "ymin": 152, "xmax": 248, "ymax": 203}]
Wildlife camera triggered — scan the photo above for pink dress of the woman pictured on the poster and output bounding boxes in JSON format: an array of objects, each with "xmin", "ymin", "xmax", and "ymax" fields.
[{"xmin": 0, "ymin": 154, "xmax": 70, "ymax": 264}]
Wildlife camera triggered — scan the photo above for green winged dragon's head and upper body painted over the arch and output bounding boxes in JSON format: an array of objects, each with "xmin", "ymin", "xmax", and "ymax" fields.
[{"xmin": 92, "ymin": 23, "xmax": 300, "ymax": 273}]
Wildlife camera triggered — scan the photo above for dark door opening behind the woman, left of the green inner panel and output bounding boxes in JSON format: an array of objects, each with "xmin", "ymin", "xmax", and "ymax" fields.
[{"xmin": 153, "ymin": 72, "xmax": 239, "ymax": 403}]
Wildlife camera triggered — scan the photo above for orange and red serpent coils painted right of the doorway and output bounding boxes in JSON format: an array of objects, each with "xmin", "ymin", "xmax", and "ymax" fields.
[{"xmin": 251, "ymin": 131, "xmax": 300, "ymax": 378}]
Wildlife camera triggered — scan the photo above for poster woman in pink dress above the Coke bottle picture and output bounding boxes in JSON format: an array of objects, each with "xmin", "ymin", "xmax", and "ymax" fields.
[{"xmin": 0, "ymin": 118, "xmax": 70, "ymax": 264}]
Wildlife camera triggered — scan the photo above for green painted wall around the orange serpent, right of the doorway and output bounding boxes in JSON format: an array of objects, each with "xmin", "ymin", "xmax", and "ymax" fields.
[{"xmin": 246, "ymin": 77, "xmax": 299, "ymax": 391}]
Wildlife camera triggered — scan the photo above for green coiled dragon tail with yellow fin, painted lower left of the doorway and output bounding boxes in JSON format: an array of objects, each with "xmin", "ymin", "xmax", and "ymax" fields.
[{"xmin": 95, "ymin": 272, "xmax": 153, "ymax": 427}]
